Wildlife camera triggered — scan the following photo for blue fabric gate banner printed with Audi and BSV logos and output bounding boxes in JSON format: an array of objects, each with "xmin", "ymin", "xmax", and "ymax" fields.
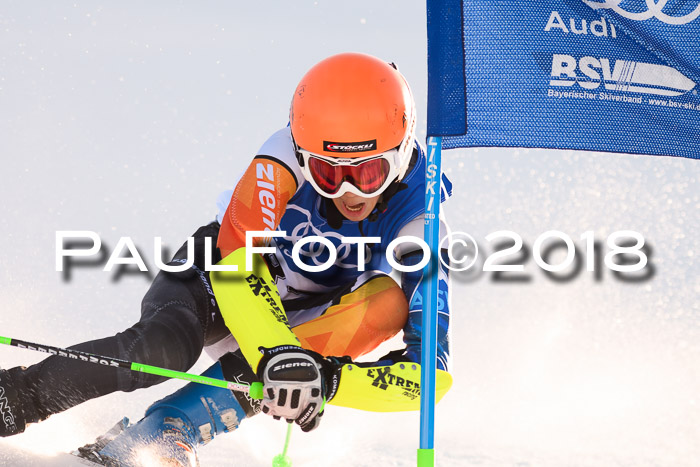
[{"xmin": 428, "ymin": 0, "xmax": 700, "ymax": 158}]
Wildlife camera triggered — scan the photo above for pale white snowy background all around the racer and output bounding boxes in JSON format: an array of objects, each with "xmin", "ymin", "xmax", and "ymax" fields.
[{"xmin": 0, "ymin": 1, "xmax": 700, "ymax": 467}]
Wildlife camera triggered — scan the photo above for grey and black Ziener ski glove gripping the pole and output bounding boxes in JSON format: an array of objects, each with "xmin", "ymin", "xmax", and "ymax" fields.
[{"xmin": 258, "ymin": 345, "xmax": 345, "ymax": 431}]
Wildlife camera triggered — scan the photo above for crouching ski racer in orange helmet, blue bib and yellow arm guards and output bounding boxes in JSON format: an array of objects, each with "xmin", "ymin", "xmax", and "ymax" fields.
[{"xmin": 0, "ymin": 53, "xmax": 451, "ymax": 466}]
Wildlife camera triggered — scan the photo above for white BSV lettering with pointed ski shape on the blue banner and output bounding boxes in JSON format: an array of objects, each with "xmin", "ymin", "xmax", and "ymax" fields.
[{"xmin": 549, "ymin": 54, "xmax": 695, "ymax": 96}]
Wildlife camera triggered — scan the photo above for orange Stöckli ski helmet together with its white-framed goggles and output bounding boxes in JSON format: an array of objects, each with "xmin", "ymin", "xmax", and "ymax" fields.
[{"xmin": 289, "ymin": 53, "xmax": 416, "ymax": 198}]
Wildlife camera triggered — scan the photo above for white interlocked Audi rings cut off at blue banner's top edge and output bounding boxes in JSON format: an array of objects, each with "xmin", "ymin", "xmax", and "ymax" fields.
[{"xmin": 583, "ymin": 0, "xmax": 700, "ymax": 24}]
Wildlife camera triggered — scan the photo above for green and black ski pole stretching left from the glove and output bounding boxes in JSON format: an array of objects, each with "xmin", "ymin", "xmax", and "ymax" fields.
[{"xmin": 0, "ymin": 336, "xmax": 263, "ymax": 399}]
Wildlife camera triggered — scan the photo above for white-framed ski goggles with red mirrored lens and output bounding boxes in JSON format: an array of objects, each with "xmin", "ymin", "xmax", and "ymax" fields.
[{"xmin": 297, "ymin": 148, "xmax": 399, "ymax": 198}]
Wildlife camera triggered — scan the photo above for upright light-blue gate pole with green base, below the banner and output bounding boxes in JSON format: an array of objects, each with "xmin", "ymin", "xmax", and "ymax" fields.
[{"xmin": 418, "ymin": 136, "xmax": 442, "ymax": 467}]
